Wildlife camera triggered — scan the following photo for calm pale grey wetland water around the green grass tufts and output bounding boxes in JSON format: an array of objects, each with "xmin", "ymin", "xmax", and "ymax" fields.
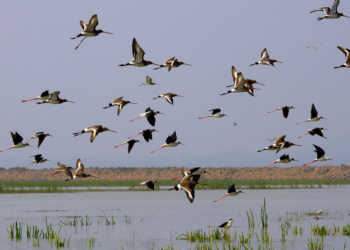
[{"xmin": 0, "ymin": 188, "xmax": 350, "ymax": 250}]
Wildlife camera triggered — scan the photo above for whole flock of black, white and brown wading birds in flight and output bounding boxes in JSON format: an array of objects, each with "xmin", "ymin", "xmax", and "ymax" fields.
[{"xmin": 0, "ymin": 0, "xmax": 350, "ymax": 228}]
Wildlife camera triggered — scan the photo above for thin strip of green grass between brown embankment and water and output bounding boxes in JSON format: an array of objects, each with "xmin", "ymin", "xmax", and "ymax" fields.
[{"xmin": 0, "ymin": 179, "xmax": 350, "ymax": 193}]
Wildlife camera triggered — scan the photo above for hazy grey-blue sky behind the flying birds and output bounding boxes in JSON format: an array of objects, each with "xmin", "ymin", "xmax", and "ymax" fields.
[{"xmin": 0, "ymin": 0, "xmax": 350, "ymax": 168}]
